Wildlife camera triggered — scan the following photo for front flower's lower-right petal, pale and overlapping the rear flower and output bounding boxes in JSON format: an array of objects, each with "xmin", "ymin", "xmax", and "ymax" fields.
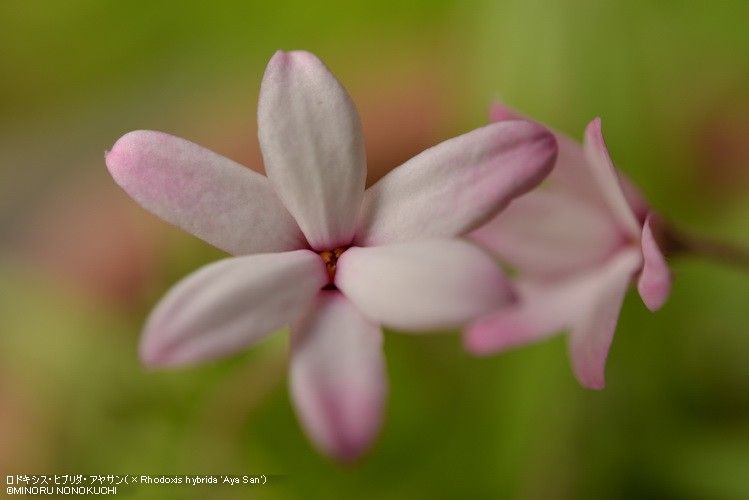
[{"xmin": 335, "ymin": 240, "xmax": 514, "ymax": 330}]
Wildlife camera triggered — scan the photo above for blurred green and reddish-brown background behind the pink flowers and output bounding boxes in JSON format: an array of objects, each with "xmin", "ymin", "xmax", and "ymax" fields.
[{"xmin": 0, "ymin": 0, "xmax": 749, "ymax": 500}]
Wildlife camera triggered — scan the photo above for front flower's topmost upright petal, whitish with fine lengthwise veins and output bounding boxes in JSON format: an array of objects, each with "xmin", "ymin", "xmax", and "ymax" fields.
[{"xmin": 258, "ymin": 51, "xmax": 366, "ymax": 250}]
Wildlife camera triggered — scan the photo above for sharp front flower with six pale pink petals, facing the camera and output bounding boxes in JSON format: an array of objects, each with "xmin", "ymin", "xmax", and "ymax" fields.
[{"xmin": 106, "ymin": 51, "xmax": 556, "ymax": 460}]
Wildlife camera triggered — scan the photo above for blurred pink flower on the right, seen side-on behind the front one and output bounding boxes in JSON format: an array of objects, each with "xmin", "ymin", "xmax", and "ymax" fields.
[{"xmin": 465, "ymin": 104, "xmax": 671, "ymax": 389}]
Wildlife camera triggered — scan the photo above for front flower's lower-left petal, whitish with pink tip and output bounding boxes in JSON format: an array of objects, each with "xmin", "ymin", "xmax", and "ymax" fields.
[{"xmin": 140, "ymin": 250, "xmax": 328, "ymax": 366}]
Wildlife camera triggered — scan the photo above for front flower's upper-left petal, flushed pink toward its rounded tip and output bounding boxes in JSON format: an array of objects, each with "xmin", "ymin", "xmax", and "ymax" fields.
[{"xmin": 106, "ymin": 130, "xmax": 305, "ymax": 255}]
